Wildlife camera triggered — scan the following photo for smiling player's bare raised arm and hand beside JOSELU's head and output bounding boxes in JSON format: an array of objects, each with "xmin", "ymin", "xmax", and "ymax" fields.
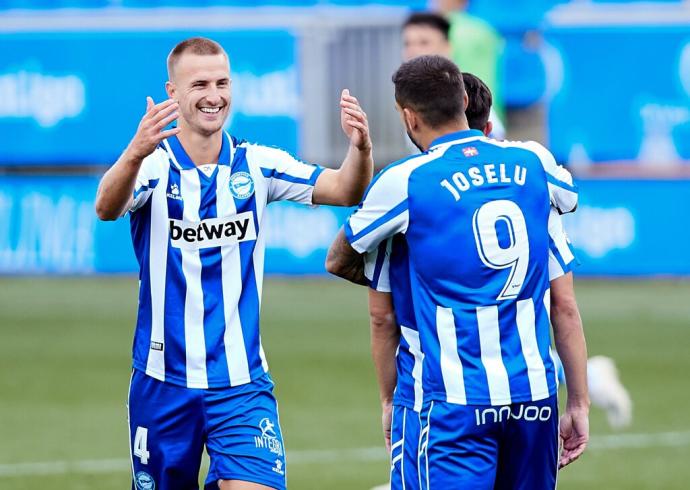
[{"xmin": 313, "ymin": 89, "xmax": 374, "ymax": 206}]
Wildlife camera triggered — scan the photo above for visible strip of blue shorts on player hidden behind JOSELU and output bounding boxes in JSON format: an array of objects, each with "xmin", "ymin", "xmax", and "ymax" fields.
[{"xmin": 391, "ymin": 405, "xmax": 420, "ymax": 490}]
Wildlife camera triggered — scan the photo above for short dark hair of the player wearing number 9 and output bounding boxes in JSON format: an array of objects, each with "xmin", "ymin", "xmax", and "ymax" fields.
[{"xmin": 393, "ymin": 56, "xmax": 465, "ymax": 128}]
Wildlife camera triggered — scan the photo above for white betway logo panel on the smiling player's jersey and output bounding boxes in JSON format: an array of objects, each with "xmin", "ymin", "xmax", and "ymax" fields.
[{"xmin": 170, "ymin": 211, "xmax": 256, "ymax": 250}]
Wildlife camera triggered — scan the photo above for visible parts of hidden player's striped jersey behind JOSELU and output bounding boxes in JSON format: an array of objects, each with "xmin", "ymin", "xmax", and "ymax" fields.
[{"xmin": 365, "ymin": 208, "xmax": 575, "ymax": 412}]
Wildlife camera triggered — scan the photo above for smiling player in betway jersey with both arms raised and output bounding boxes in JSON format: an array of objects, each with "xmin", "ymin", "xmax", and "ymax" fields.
[{"xmin": 96, "ymin": 38, "xmax": 373, "ymax": 490}]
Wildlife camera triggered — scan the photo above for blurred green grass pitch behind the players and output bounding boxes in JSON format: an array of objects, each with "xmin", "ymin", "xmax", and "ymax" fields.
[{"xmin": 0, "ymin": 277, "xmax": 690, "ymax": 490}]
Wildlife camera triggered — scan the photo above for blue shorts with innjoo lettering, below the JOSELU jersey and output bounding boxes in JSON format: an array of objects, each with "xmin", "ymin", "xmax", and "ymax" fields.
[{"xmin": 419, "ymin": 395, "xmax": 558, "ymax": 490}]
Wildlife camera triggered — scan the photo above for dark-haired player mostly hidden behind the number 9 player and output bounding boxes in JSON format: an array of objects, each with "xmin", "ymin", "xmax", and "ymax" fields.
[{"xmin": 364, "ymin": 72, "xmax": 575, "ymax": 490}]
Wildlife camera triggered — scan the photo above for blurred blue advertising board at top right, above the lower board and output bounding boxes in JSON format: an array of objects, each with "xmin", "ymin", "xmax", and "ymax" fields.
[{"xmin": 543, "ymin": 24, "xmax": 690, "ymax": 164}]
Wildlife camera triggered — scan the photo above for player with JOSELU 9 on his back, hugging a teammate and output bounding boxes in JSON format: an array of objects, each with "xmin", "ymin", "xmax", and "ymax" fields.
[{"xmin": 327, "ymin": 56, "xmax": 589, "ymax": 489}]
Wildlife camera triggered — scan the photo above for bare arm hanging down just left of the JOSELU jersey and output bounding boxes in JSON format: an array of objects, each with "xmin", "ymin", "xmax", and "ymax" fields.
[{"xmin": 369, "ymin": 289, "xmax": 400, "ymax": 451}]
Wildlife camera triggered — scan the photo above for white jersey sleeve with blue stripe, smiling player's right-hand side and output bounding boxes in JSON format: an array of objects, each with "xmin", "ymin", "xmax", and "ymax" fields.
[{"xmin": 247, "ymin": 145, "xmax": 324, "ymax": 204}]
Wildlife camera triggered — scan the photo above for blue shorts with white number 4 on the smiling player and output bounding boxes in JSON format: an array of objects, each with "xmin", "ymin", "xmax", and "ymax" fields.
[{"xmin": 128, "ymin": 370, "xmax": 286, "ymax": 490}]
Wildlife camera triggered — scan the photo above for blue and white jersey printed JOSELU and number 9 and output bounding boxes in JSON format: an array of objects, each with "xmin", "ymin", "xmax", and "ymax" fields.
[{"xmin": 345, "ymin": 130, "xmax": 577, "ymax": 405}]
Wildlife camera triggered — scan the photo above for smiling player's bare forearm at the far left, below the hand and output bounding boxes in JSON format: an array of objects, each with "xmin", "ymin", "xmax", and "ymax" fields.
[{"xmin": 96, "ymin": 149, "xmax": 142, "ymax": 220}]
